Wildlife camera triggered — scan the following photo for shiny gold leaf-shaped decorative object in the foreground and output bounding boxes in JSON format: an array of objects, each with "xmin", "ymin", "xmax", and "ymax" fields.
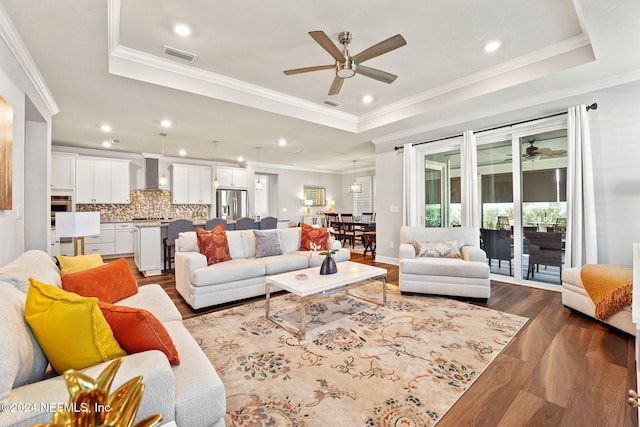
[{"xmin": 33, "ymin": 359, "xmax": 162, "ymax": 427}]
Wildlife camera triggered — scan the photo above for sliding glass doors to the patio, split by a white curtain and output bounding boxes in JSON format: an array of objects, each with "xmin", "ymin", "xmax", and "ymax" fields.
[{"xmin": 416, "ymin": 116, "xmax": 567, "ymax": 287}]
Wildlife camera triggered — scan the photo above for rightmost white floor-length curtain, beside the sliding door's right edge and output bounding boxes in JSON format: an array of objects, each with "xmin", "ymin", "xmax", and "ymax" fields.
[{"xmin": 564, "ymin": 105, "xmax": 598, "ymax": 267}]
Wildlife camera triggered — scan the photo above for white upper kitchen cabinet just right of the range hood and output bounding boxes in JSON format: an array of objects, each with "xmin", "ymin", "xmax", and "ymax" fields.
[{"xmin": 171, "ymin": 164, "xmax": 212, "ymax": 205}]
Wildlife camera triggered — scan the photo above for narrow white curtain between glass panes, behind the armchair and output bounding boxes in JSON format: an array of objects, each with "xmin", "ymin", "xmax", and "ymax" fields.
[{"xmin": 460, "ymin": 130, "xmax": 480, "ymax": 227}]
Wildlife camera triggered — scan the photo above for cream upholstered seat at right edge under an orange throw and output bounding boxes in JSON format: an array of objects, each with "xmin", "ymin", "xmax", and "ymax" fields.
[{"xmin": 562, "ymin": 267, "xmax": 636, "ymax": 335}]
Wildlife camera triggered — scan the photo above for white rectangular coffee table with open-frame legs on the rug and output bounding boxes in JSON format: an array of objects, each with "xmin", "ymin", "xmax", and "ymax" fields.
[{"xmin": 265, "ymin": 261, "xmax": 387, "ymax": 340}]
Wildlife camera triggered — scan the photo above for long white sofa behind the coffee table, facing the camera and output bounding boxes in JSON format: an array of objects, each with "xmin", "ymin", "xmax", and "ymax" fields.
[{"xmin": 175, "ymin": 227, "xmax": 351, "ymax": 309}]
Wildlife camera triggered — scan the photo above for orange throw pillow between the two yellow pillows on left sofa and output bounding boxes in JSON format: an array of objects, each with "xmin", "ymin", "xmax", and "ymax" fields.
[{"xmin": 62, "ymin": 258, "xmax": 138, "ymax": 302}]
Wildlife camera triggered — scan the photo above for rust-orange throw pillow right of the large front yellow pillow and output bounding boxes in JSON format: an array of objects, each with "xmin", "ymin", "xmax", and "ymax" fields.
[{"xmin": 98, "ymin": 301, "xmax": 180, "ymax": 365}]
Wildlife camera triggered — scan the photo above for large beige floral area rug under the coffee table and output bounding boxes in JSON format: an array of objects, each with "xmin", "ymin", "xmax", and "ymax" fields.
[{"xmin": 185, "ymin": 284, "xmax": 527, "ymax": 427}]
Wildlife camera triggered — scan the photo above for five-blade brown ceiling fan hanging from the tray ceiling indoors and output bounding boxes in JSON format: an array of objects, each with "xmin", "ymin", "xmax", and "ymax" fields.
[{"xmin": 284, "ymin": 31, "xmax": 407, "ymax": 95}]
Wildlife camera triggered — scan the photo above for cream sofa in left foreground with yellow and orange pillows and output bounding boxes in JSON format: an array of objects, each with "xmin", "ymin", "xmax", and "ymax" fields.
[{"xmin": 0, "ymin": 250, "xmax": 226, "ymax": 427}]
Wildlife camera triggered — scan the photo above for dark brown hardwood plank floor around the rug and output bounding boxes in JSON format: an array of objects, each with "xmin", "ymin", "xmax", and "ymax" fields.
[{"xmin": 129, "ymin": 253, "xmax": 638, "ymax": 427}]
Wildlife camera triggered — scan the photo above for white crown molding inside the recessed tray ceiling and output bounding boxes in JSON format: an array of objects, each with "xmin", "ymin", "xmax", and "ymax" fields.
[{"xmin": 108, "ymin": 0, "xmax": 595, "ymax": 138}]
